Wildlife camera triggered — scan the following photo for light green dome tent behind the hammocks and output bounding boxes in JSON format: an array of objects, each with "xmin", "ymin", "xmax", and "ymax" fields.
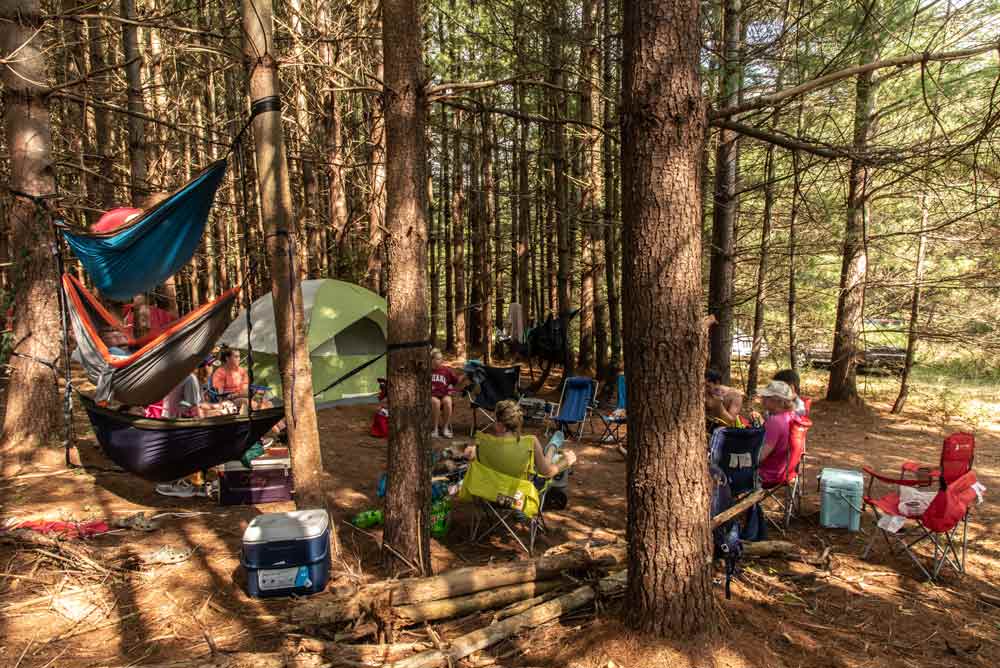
[{"xmin": 219, "ymin": 278, "xmax": 388, "ymax": 404}]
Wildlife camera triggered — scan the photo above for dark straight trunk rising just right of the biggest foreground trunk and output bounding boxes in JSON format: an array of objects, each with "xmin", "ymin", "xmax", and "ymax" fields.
[{"xmin": 708, "ymin": 0, "xmax": 742, "ymax": 384}]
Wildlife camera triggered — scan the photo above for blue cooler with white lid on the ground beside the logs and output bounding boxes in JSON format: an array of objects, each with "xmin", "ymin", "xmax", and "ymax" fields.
[{"xmin": 240, "ymin": 509, "xmax": 330, "ymax": 598}]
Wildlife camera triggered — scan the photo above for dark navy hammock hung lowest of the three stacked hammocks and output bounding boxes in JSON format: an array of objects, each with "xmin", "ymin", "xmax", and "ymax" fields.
[{"xmin": 80, "ymin": 395, "xmax": 284, "ymax": 482}]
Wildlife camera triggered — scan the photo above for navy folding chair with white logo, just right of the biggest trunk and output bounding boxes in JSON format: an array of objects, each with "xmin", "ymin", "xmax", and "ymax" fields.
[{"xmin": 709, "ymin": 427, "xmax": 765, "ymax": 540}]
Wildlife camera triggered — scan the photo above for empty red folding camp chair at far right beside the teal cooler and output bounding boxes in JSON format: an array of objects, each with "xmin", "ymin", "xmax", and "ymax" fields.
[{"xmin": 862, "ymin": 432, "xmax": 982, "ymax": 580}]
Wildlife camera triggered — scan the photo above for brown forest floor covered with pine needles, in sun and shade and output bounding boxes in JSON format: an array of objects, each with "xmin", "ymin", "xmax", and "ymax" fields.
[{"xmin": 0, "ymin": 366, "xmax": 1000, "ymax": 668}]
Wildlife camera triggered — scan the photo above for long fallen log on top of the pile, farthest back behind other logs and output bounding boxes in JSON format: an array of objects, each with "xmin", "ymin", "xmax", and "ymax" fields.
[{"xmin": 290, "ymin": 544, "xmax": 626, "ymax": 625}]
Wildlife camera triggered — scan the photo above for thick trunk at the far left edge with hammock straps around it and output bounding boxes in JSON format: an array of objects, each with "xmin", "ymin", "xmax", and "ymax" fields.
[{"xmin": 0, "ymin": 0, "xmax": 63, "ymax": 464}]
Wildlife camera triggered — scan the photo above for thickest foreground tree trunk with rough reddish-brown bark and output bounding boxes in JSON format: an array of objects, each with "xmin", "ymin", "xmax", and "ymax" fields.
[{"xmin": 621, "ymin": 0, "xmax": 716, "ymax": 636}]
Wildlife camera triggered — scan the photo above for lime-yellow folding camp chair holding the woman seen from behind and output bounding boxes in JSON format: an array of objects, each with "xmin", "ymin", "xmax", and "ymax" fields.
[{"xmin": 458, "ymin": 433, "xmax": 551, "ymax": 555}]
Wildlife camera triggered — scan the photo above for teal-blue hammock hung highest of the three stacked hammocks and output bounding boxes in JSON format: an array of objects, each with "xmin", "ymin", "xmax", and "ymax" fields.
[{"xmin": 60, "ymin": 160, "xmax": 226, "ymax": 301}]
